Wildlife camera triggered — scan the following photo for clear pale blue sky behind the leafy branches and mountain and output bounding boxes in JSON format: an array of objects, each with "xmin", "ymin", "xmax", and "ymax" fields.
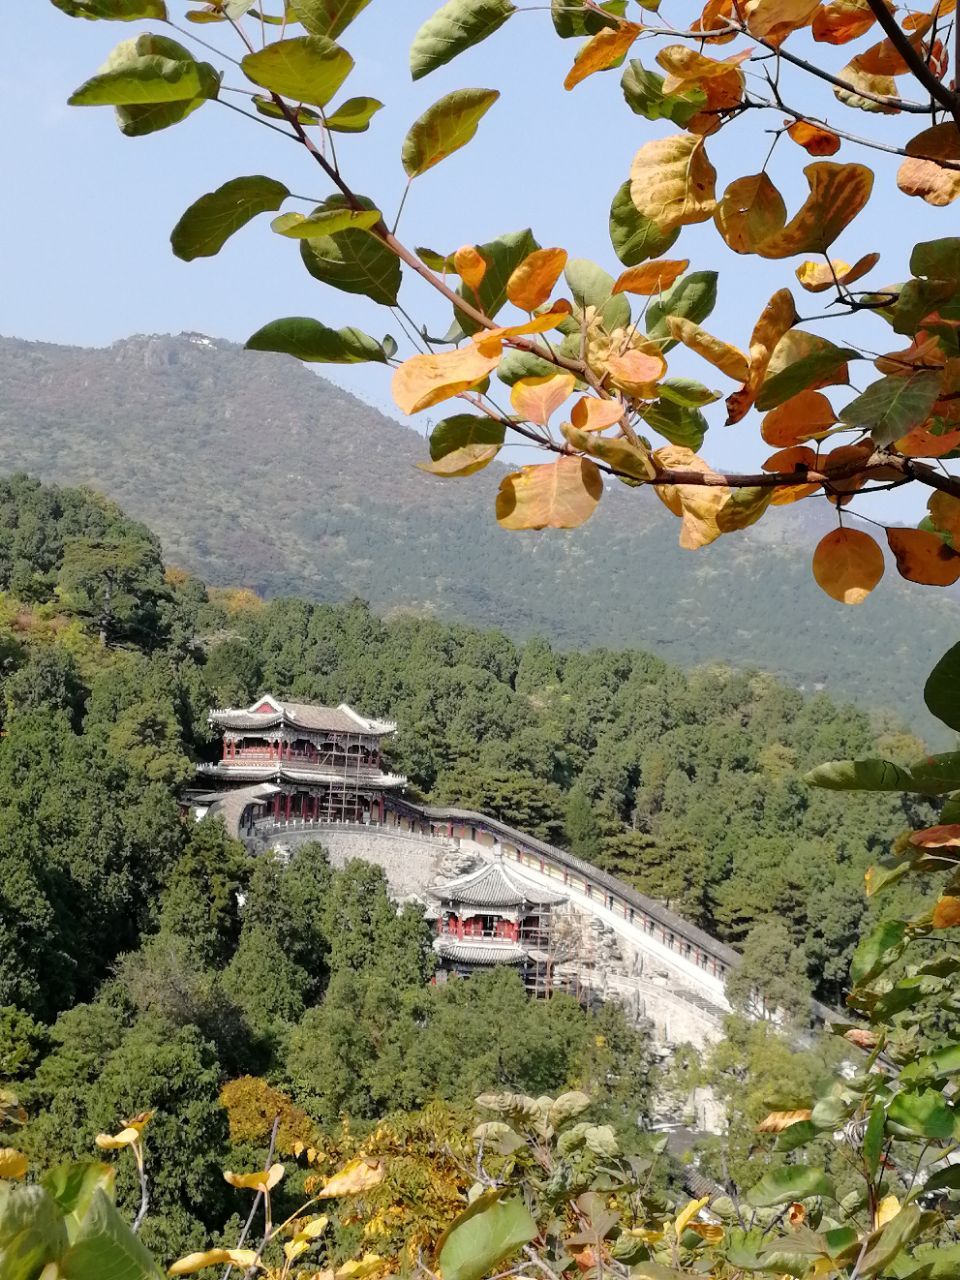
[{"xmin": 0, "ymin": 0, "xmax": 956, "ymax": 512}]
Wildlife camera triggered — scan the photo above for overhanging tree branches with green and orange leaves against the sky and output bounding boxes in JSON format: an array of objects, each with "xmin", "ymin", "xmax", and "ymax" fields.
[{"xmin": 52, "ymin": 0, "xmax": 960, "ymax": 606}]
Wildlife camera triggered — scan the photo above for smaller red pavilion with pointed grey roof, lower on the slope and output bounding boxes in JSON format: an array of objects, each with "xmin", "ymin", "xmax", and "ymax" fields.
[{"xmin": 433, "ymin": 855, "xmax": 566, "ymax": 991}]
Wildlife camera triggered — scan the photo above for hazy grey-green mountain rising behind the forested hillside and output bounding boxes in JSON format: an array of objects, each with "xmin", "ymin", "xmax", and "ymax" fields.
[{"xmin": 0, "ymin": 334, "xmax": 960, "ymax": 731}]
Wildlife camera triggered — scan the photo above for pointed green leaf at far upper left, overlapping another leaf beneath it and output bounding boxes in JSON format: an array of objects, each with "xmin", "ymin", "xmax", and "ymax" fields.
[{"xmin": 68, "ymin": 35, "xmax": 220, "ymax": 106}]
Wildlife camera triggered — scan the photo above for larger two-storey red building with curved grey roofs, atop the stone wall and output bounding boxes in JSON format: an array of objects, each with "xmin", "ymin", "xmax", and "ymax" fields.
[{"xmin": 198, "ymin": 694, "xmax": 407, "ymax": 826}]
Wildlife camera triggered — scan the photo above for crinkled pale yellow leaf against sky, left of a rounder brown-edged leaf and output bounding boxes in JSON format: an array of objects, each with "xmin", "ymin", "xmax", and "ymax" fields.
[{"xmin": 630, "ymin": 133, "xmax": 717, "ymax": 232}]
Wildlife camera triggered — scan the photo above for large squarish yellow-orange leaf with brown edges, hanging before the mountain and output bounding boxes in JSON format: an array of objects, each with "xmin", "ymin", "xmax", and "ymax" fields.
[{"xmin": 497, "ymin": 458, "xmax": 603, "ymax": 529}]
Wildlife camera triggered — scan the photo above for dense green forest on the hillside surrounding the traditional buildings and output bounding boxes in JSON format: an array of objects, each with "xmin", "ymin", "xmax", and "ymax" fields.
[{"xmin": 0, "ymin": 476, "xmax": 918, "ymax": 1256}]
